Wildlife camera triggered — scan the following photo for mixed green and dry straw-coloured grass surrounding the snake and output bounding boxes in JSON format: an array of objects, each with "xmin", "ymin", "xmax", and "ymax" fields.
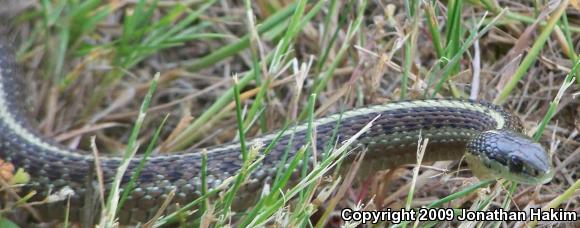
[{"xmin": 0, "ymin": 0, "xmax": 580, "ymax": 227}]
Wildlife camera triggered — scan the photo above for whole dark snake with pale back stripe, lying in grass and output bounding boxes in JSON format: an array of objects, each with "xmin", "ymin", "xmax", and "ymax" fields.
[{"xmin": 0, "ymin": 42, "xmax": 554, "ymax": 223}]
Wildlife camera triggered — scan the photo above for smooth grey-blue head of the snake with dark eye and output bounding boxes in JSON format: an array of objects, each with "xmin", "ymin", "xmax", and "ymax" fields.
[{"xmin": 466, "ymin": 130, "xmax": 554, "ymax": 185}]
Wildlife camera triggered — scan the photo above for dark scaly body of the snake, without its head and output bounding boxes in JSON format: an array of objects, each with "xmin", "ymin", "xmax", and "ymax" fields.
[{"xmin": 0, "ymin": 42, "xmax": 536, "ymax": 223}]
